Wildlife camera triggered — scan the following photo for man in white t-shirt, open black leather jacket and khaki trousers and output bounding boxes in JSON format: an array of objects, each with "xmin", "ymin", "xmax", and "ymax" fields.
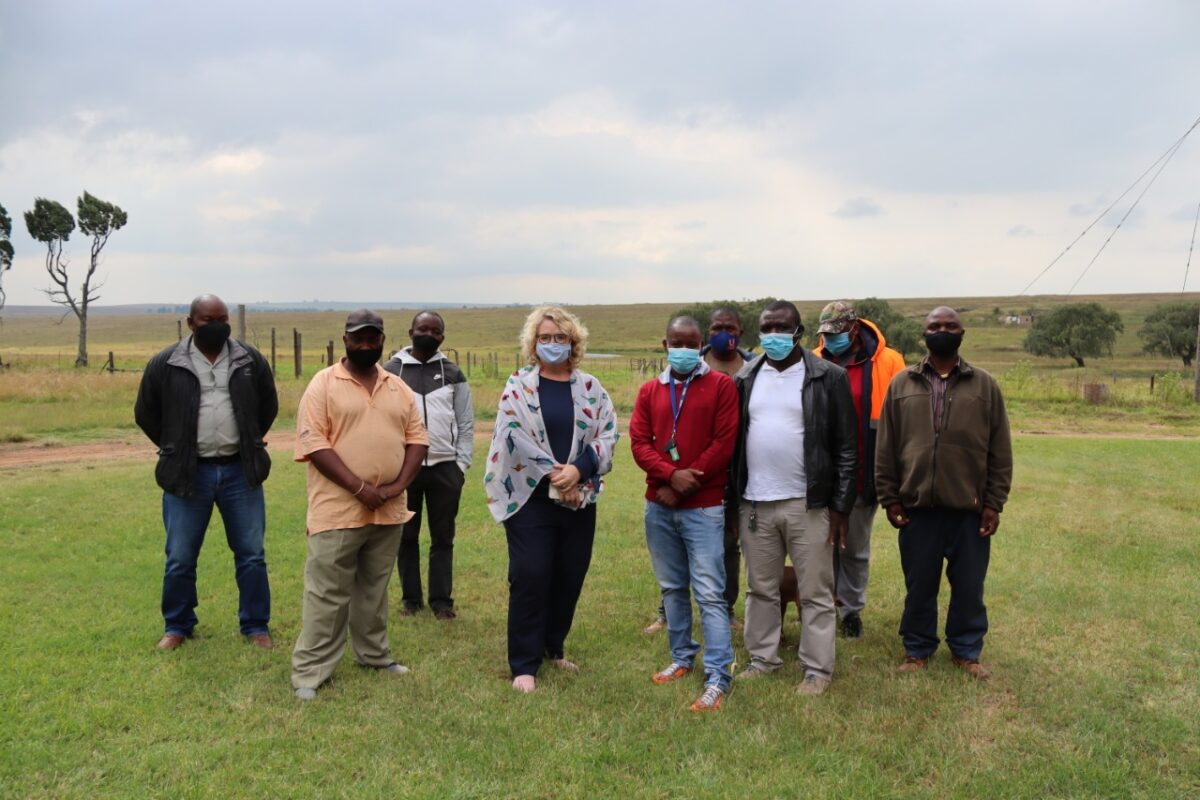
[{"xmin": 730, "ymin": 300, "xmax": 858, "ymax": 694}]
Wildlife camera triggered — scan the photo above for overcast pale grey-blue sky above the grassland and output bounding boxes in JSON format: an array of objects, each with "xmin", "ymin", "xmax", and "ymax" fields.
[{"xmin": 0, "ymin": 0, "xmax": 1200, "ymax": 305}]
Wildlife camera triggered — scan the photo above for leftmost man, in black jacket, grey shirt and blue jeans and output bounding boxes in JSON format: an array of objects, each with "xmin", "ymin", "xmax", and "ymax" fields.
[{"xmin": 133, "ymin": 295, "xmax": 278, "ymax": 650}]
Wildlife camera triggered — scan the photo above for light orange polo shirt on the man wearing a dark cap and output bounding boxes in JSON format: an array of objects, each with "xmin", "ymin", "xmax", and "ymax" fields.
[{"xmin": 294, "ymin": 362, "xmax": 430, "ymax": 535}]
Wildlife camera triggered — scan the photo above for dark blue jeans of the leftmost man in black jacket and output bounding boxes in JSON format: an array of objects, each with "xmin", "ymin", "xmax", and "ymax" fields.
[{"xmin": 162, "ymin": 462, "xmax": 271, "ymax": 636}]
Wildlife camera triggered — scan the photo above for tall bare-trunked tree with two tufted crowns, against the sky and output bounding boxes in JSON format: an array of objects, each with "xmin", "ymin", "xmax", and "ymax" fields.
[{"xmin": 25, "ymin": 192, "xmax": 128, "ymax": 367}]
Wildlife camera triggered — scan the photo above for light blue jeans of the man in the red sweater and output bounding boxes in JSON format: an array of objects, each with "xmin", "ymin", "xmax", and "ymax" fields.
[{"xmin": 646, "ymin": 500, "xmax": 733, "ymax": 688}]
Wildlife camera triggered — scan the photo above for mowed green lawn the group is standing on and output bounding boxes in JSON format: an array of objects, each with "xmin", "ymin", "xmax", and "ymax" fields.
[{"xmin": 0, "ymin": 437, "xmax": 1200, "ymax": 798}]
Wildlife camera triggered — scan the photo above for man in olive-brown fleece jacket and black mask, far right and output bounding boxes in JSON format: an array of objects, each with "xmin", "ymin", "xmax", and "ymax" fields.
[{"xmin": 875, "ymin": 306, "xmax": 1013, "ymax": 679}]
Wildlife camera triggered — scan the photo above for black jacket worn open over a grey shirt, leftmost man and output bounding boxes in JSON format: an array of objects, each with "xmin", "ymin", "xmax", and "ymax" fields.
[{"xmin": 133, "ymin": 339, "xmax": 280, "ymax": 497}]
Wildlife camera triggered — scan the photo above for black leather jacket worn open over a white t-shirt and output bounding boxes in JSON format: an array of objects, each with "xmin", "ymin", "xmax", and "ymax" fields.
[{"xmin": 730, "ymin": 345, "xmax": 858, "ymax": 513}]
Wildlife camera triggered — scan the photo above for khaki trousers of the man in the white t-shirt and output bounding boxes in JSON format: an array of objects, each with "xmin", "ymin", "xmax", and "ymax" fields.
[{"xmin": 738, "ymin": 498, "xmax": 838, "ymax": 678}]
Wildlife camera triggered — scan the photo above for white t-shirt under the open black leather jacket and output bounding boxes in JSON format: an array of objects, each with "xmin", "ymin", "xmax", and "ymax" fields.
[{"xmin": 743, "ymin": 360, "xmax": 808, "ymax": 500}]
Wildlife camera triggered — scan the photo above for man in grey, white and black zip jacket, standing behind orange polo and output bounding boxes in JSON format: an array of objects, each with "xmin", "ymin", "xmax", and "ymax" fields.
[{"xmin": 384, "ymin": 312, "xmax": 475, "ymax": 619}]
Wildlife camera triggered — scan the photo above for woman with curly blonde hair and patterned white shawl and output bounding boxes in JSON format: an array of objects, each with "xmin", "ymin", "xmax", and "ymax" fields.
[{"xmin": 484, "ymin": 306, "xmax": 618, "ymax": 692}]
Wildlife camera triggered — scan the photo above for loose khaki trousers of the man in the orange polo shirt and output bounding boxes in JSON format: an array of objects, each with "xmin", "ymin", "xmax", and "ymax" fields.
[{"xmin": 292, "ymin": 525, "xmax": 404, "ymax": 688}]
